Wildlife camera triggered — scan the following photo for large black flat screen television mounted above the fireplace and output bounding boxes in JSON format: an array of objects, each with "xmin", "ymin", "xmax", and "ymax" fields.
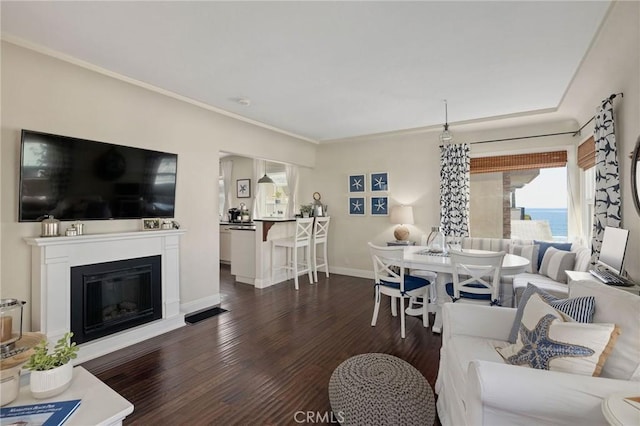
[{"xmin": 18, "ymin": 130, "xmax": 178, "ymax": 222}]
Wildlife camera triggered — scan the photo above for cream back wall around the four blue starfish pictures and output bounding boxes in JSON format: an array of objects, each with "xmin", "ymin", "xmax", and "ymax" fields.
[{"xmin": 299, "ymin": 134, "xmax": 440, "ymax": 275}]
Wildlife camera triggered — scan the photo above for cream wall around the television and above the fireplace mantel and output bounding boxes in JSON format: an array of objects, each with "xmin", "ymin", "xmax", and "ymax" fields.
[{"xmin": 0, "ymin": 42, "xmax": 316, "ymax": 330}]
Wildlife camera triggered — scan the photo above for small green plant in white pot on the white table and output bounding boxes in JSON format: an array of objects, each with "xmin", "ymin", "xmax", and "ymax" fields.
[{"xmin": 24, "ymin": 332, "xmax": 79, "ymax": 399}]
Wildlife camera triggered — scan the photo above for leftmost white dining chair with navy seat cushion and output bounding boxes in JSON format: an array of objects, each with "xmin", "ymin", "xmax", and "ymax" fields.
[{"xmin": 368, "ymin": 243, "xmax": 431, "ymax": 339}]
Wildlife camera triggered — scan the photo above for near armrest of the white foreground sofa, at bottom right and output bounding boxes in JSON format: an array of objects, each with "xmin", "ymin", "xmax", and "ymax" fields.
[{"xmin": 465, "ymin": 360, "xmax": 640, "ymax": 426}]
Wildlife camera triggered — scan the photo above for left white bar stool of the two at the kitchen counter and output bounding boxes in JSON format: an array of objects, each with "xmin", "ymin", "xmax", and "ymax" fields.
[{"xmin": 271, "ymin": 217, "xmax": 313, "ymax": 290}]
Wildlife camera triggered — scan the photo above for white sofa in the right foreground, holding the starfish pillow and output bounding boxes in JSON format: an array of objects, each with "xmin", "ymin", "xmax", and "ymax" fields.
[{"xmin": 435, "ymin": 281, "xmax": 640, "ymax": 426}]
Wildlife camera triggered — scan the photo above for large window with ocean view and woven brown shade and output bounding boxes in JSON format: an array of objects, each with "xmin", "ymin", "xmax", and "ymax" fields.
[{"xmin": 469, "ymin": 151, "xmax": 568, "ymax": 241}]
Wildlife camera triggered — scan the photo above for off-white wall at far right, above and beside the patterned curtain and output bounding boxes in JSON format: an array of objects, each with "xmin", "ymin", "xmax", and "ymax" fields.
[{"xmin": 560, "ymin": 1, "xmax": 640, "ymax": 281}]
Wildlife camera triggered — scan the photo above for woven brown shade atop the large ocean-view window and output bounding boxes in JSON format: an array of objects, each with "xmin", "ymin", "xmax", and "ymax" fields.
[{"xmin": 471, "ymin": 151, "xmax": 567, "ymax": 174}]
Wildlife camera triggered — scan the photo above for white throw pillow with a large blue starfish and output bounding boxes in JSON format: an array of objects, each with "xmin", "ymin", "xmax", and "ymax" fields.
[{"xmin": 496, "ymin": 294, "xmax": 620, "ymax": 377}]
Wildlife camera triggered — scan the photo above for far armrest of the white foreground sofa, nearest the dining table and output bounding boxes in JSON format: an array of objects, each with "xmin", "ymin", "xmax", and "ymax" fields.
[{"xmin": 442, "ymin": 302, "xmax": 516, "ymax": 344}]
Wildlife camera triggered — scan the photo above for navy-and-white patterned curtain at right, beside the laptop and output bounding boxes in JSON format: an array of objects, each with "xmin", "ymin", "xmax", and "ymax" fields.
[{"xmin": 591, "ymin": 99, "xmax": 622, "ymax": 263}]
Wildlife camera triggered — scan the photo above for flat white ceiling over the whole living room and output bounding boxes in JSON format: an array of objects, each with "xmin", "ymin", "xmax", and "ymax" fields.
[{"xmin": 1, "ymin": 0, "xmax": 610, "ymax": 141}]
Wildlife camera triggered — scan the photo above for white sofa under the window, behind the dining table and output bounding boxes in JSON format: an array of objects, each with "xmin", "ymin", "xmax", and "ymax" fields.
[{"xmin": 461, "ymin": 237, "xmax": 591, "ymax": 306}]
